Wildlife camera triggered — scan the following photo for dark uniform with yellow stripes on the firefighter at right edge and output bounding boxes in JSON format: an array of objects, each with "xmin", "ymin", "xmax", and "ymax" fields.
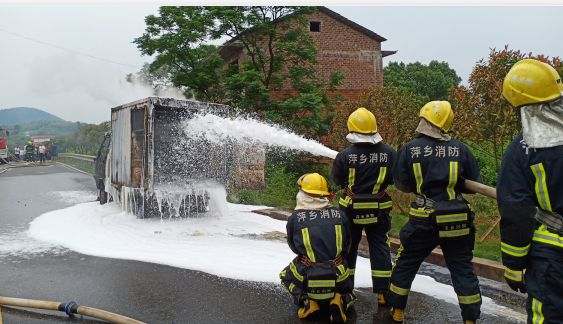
[{"xmin": 497, "ymin": 135, "xmax": 563, "ymax": 324}]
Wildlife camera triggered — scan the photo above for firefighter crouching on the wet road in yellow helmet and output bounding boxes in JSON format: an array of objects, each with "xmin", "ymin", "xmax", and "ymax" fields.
[{"xmin": 280, "ymin": 173, "xmax": 356, "ymax": 322}]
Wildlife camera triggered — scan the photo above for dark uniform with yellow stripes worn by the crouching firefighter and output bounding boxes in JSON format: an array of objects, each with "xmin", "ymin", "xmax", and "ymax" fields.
[{"xmin": 280, "ymin": 207, "xmax": 355, "ymax": 308}]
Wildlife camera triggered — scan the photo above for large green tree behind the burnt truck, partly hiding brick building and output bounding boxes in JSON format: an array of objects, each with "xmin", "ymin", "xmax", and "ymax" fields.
[{"xmin": 134, "ymin": 6, "xmax": 342, "ymax": 135}]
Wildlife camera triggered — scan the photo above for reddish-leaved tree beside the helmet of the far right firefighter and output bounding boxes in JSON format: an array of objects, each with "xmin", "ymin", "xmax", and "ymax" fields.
[{"xmin": 452, "ymin": 46, "xmax": 563, "ymax": 171}]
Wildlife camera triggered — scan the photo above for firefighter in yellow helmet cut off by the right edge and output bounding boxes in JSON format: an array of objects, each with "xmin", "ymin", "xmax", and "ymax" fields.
[{"xmin": 497, "ymin": 59, "xmax": 563, "ymax": 324}]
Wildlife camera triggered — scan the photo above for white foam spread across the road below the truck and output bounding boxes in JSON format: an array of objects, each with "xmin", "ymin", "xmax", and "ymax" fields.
[{"xmin": 22, "ymin": 202, "xmax": 525, "ymax": 321}]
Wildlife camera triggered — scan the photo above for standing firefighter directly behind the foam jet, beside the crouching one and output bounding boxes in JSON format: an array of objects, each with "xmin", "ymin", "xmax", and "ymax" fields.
[{"xmin": 332, "ymin": 108, "xmax": 397, "ymax": 306}]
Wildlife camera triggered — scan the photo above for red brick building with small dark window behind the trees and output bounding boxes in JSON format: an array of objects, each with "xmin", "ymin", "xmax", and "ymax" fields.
[{"xmin": 219, "ymin": 7, "xmax": 397, "ymax": 99}]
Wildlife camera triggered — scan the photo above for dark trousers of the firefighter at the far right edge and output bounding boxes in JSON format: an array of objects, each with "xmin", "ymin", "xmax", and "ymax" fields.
[{"xmin": 525, "ymin": 254, "xmax": 563, "ymax": 324}]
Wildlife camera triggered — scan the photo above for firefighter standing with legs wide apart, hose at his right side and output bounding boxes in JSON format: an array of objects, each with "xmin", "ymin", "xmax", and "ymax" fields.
[{"xmin": 388, "ymin": 101, "xmax": 481, "ymax": 323}]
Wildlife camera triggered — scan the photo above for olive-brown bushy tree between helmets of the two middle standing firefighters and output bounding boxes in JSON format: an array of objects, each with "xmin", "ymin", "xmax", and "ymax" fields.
[{"xmin": 331, "ymin": 85, "xmax": 427, "ymax": 148}]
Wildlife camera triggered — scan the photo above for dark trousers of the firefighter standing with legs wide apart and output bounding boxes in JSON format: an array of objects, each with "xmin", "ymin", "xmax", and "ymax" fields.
[{"xmin": 388, "ymin": 218, "xmax": 481, "ymax": 320}]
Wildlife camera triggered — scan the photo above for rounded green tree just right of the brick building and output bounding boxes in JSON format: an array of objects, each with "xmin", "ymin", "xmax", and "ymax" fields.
[{"xmin": 383, "ymin": 61, "xmax": 461, "ymax": 101}]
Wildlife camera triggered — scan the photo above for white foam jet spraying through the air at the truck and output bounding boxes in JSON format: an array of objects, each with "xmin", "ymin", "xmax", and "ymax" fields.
[{"xmin": 182, "ymin": 114, "xmax": 338, "ymax": 159}]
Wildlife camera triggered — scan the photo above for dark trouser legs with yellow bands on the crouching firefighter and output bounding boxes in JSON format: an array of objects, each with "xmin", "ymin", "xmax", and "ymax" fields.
[{"xmin": 280, "ymin": 257, "xmax": 355, "ymax": 306}]
